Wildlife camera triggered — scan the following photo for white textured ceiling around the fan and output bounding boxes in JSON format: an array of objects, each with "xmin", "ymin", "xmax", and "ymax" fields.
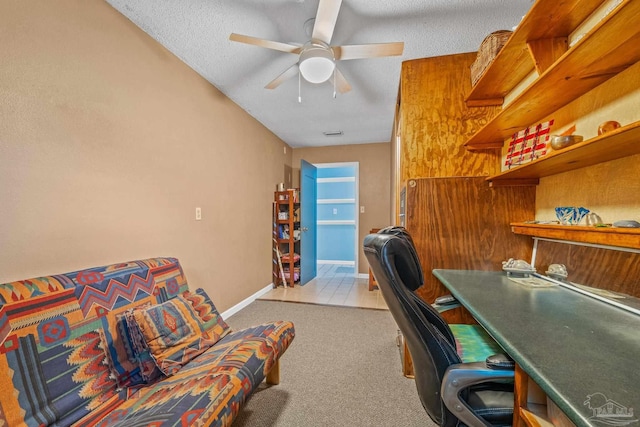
[{"xmin": 107, "ymin": 0, "xmax": 532, "ymax": 147}]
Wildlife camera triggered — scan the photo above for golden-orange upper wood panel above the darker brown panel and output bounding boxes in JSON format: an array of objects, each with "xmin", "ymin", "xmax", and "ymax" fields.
[{"xmin": 397, "ymin": 53, "xmax": 500, "ymax": 184}]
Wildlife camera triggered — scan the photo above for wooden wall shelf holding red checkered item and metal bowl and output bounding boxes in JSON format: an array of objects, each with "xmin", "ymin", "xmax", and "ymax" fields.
[{"xmin": 487, "ymin": 122, "xmax": 640, "ymax": 186}]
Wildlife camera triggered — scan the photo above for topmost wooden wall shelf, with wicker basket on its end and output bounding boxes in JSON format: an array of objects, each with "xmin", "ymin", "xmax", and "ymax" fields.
[{"xmin": 467, "ymin": 0, "xmax": 604, "ymax": 103}]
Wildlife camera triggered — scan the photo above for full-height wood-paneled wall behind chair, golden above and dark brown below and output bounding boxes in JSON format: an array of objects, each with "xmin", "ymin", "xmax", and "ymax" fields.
[{"xmin": 395, "ymin": 53, "xmax": 535, "ymax": 323}]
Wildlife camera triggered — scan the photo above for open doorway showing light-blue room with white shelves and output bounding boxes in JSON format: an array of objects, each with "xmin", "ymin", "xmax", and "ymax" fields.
[{"xmin": 314, "ymin": 162, "xmax": 359, "ymax": 276}]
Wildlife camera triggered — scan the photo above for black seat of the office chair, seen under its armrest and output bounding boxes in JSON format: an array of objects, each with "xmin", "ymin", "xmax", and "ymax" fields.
[{"xmin": 467, "ymin": 383, "xmax": 514, "ymax": 426}]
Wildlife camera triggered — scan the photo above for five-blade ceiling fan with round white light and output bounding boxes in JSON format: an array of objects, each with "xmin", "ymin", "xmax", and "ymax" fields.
[{"xmin": 229, "ymin": 0, "xmax": 404, "ymax": 96}]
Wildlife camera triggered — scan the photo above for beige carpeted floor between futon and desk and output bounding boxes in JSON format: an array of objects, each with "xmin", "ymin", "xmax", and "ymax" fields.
[{"xmin": 226, "ymin": 301, "xmax": 435, "ymax": 427}]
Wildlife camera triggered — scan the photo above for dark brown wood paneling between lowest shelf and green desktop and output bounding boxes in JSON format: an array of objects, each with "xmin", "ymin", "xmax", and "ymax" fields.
[{"xmin": 535, "ymin": 241, "xmax": 640, "ymax": 298}]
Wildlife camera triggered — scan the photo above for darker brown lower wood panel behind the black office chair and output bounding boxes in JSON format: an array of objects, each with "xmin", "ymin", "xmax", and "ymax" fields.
[{"xmin": 407, "ymin": 177, "xmax": 535, "ymax": 323}]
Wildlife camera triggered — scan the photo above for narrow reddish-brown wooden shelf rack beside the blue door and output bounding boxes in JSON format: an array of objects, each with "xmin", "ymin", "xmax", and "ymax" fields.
[{"xmin": 273, "ymin": 188, "xmax": 301, "ymax": 287}]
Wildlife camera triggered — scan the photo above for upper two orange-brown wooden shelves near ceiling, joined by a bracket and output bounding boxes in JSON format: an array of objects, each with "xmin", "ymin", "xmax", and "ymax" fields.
[{"xmin": 465, "ymin": 0, "xmax": 640, "ymax": 151}]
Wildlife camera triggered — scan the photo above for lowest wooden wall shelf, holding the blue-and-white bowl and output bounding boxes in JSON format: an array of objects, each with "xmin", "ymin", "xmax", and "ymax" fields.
[{"xmin": 511, "ymin": 222, "xmax": 640, "ymax": 249}]
